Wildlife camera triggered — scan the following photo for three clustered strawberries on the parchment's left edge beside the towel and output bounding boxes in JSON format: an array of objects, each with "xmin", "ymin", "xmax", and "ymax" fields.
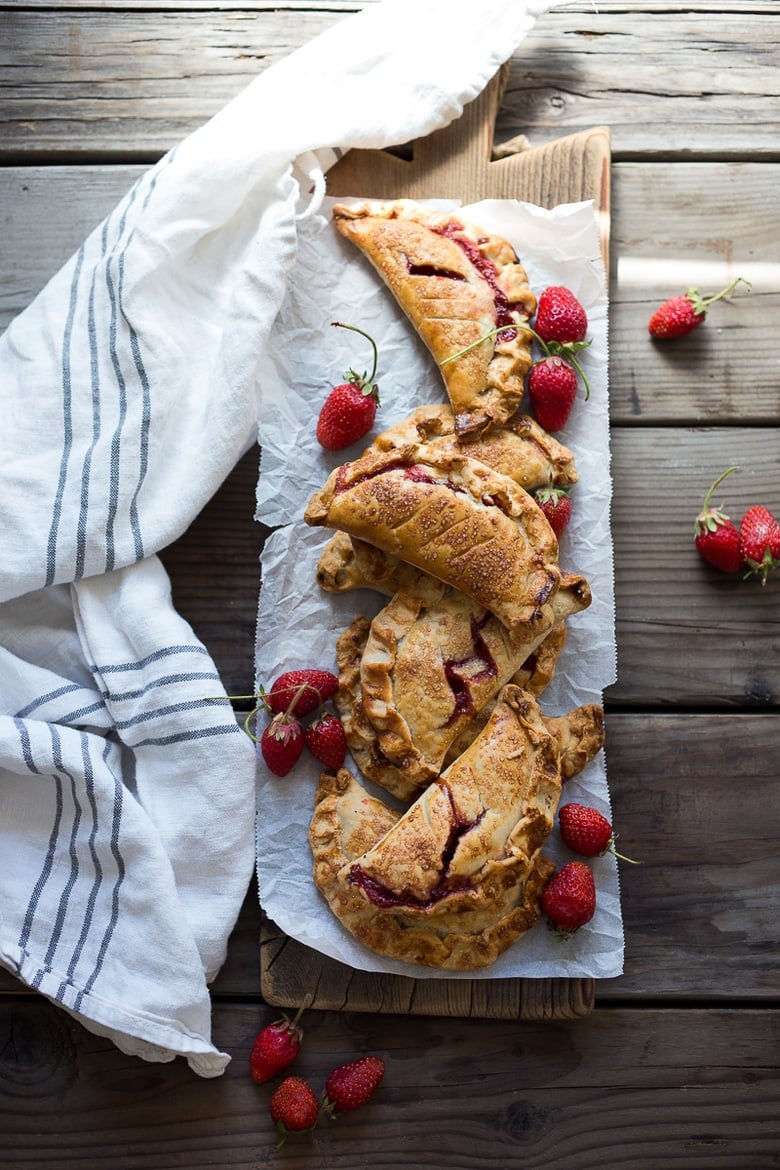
[{"xmin": 253, "ymin": 668, "xmax": 346, "ymax": 776}]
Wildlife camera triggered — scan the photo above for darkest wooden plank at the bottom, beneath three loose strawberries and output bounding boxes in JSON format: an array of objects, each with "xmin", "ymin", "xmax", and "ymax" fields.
[{"xmin": 0, "ymin": 999, "xmax": 780, "ymax": 1170}]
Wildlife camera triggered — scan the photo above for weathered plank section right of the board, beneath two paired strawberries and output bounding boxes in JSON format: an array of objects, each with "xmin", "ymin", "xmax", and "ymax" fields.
[{"xmin": 608, "ymin": 426, "xmax": 780, "ymax": 709}]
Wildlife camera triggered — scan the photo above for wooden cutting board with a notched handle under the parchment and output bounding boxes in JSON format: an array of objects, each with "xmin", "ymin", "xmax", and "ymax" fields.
[{"xmin": 260, "ymin": 67, "xmax": 610, "ymax": 1020}]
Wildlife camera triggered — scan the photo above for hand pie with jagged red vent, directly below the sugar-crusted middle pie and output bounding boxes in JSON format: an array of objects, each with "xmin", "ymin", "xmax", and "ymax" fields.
[{"xmin": 334, "ymin": 573, "xmax": 591, "ymax": 800}]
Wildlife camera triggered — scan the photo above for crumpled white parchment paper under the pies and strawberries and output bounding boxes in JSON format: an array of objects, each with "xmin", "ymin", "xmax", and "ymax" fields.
[{"xmin": 256, "ymin": 199, "xmax": 623, "ymax": 979}]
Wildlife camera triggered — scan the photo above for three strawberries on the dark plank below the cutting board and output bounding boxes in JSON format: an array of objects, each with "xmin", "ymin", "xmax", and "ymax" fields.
[{"xmin": 249, "ymin": 999, "xmax": 385, "ymax": 1145}]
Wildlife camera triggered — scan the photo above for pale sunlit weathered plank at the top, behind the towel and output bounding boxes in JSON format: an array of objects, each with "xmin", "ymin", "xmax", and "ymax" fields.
[{"xmin": 0, "ymin": 2, "xmax": 780, "ymax": 160}]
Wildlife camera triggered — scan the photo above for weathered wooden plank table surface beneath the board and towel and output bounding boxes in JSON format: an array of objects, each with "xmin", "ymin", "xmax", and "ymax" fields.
[{"xmin": 0, "ymin": 0, "xmax": 780, "ymax": 1170}]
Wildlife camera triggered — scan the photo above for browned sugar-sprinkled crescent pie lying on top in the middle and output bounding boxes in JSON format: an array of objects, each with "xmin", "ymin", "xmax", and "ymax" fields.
[{"xmin": 304, "ymin": 443, "xmax": 560, "ymax": 629}]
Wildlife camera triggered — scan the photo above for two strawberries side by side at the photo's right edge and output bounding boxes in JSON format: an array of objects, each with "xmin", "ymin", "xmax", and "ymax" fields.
[{"xmin": 695, "ymin": 467, "xmax": 780, "ymax": 585}]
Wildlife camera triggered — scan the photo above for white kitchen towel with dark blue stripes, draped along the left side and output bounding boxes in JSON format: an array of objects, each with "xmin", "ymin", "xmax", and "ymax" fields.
[{"xmin": 0, "ymin": 0, "xmax": 573, "ymax": 1075}]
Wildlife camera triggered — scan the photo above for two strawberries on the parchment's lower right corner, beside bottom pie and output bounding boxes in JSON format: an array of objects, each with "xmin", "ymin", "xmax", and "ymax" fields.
[{"xmin": 541, "ymin": 801, "xmax": 637, "ymax": 937}]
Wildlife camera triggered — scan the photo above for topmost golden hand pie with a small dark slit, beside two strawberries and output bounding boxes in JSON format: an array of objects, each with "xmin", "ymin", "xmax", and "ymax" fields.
[{"xmin": 333, "ymin": 199, "xmax": 537, "ymax": 435}]
